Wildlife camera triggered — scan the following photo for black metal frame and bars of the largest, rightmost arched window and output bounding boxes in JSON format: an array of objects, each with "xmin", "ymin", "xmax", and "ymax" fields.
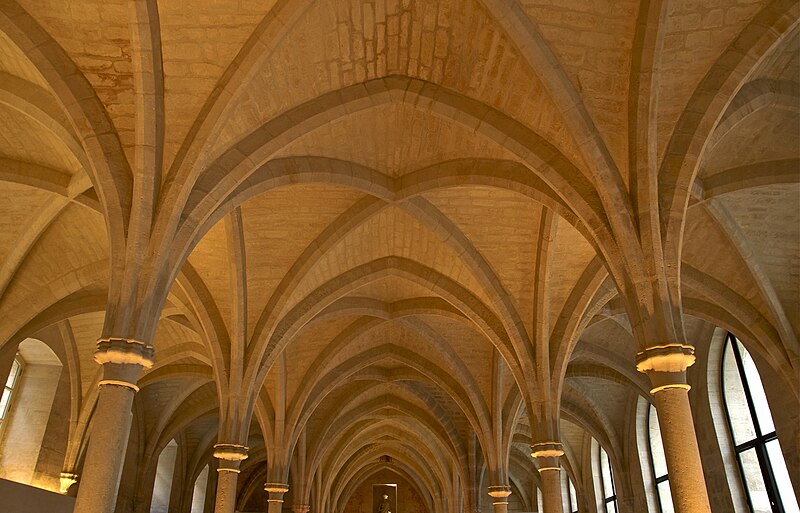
[{"xmin": 720, "ymin": 332, "xmax": 786, "ymax": 513}]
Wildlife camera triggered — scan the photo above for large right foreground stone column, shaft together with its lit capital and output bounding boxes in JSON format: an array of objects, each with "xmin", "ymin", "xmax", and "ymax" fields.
[{"xmin": 636, "ymin": 344, "xmax": 711, "ymax": 513}]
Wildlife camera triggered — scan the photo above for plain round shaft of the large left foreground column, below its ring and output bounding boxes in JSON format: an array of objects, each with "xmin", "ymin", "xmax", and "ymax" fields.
[{"xmin": 74, "ymin": 384, "xmax": 134, "ymax": 513}]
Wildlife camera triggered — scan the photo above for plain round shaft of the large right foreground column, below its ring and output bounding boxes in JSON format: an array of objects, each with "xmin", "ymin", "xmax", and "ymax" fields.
[{"xmin": 654, "ymin": 387, "xmax": 711, "ymax": 513}]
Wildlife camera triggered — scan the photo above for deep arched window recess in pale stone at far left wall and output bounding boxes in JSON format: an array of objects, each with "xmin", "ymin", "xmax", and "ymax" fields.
[{"xmin": 0, "ymin": 338, "xmax": 63, "ymax": 491}]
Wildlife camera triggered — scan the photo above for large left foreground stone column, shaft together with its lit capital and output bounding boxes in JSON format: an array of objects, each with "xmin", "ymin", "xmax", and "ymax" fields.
[{"xmin": 74, "ymin": 338, "xmax": 153, "ymax": 513}]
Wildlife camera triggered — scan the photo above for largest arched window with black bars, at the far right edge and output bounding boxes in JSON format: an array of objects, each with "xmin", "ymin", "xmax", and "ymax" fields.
[{"xmin": 722, "ymin": 333, "xmax": 800, "ymax": 513}]
